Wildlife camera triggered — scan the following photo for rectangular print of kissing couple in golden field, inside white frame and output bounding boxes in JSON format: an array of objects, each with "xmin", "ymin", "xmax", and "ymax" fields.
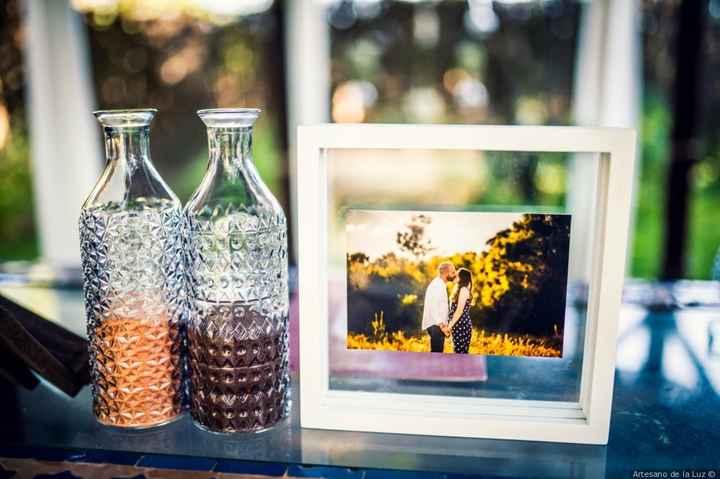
[{"xmin": 344, "ymin": 208, "xmax": 571, "ymax": 358}]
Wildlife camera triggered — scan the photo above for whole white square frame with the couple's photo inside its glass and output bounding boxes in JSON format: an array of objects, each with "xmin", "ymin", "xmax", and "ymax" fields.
[{"xmin": 297, "ymin": 124, "xmax": 635, "ymax": 444}]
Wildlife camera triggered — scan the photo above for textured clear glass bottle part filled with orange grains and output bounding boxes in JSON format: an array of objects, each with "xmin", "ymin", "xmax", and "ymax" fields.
[{"xmin": 80, "ymin": 110, "xmax": 187, "ymax": 427}]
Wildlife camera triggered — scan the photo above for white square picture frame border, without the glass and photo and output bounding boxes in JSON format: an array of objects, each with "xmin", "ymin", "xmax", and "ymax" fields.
[{"xmin": 297, "ymin": 124, "xmax": 636, "ymax": 444}]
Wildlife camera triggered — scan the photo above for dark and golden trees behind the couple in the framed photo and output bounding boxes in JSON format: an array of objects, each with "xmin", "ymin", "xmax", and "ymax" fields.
[{"xmin": 347, "ymin": 214, "xmax": 570, "ymax": 341}]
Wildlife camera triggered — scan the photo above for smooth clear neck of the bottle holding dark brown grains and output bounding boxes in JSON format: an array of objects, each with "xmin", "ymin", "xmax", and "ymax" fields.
[{"xmin": 208, "ymin": 127, "xmax": 252, "ymax": 180}]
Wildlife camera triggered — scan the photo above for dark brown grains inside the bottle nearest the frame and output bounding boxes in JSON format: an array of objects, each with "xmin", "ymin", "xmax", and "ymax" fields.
[{"xmin": 188, "ymin": 328, "xmax": 288, "ymax": 432}]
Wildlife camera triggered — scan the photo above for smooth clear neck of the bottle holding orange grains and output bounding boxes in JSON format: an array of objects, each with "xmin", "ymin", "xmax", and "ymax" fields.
[{"xmin": 105, "ymin": 126, "xmax": 150, "ymax": 172}]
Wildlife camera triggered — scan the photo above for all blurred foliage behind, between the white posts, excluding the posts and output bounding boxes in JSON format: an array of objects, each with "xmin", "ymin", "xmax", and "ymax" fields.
[{"xmin": 0, "ymin": 0, "xmax": 720, "ymax": 278}]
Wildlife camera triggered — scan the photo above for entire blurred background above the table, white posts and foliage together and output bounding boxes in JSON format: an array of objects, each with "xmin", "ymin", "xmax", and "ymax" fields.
[{"xmin": 0, "ymin": 0, "xmax": 720, "ymax": 279}]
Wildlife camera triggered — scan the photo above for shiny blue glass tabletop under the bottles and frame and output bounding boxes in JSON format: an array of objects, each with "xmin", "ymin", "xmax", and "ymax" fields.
[{"xmin": 0, "ymin": 283, "xmax": 720, "ymax": 478}]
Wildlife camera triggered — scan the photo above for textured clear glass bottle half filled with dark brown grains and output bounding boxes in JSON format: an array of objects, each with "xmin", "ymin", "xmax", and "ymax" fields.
[{"xmin": 185, "ymin": 109, "xmax": 290, "ymax": 432}]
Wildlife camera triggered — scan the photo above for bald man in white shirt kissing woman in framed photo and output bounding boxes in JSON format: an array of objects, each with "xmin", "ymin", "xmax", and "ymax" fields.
[{"xmin": 422, "ymin": 262, "xmax": 455, "ymax": 353}]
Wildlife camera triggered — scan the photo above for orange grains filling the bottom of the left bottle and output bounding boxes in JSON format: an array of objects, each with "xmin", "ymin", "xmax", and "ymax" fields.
[{"xmin": 91, "ymin": 317, "xmax": 182, "ymax": 427}]
